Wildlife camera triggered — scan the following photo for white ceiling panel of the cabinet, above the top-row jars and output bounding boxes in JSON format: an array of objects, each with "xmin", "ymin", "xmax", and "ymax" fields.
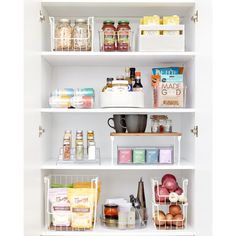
[{"xmin": 41, "ymin": 0, "xmax": 195, "ymax": 17}]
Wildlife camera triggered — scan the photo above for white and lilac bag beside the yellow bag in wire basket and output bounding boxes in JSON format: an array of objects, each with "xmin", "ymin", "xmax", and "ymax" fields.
[{"xmin": 48, "ymin": 188, "xmax": 71, "ymax": 226}]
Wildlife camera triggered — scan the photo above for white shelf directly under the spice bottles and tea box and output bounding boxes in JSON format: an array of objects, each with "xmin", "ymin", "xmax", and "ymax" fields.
[{"xmin": 41, "ymin": 159, "xmax": 194, "ymax": 170}]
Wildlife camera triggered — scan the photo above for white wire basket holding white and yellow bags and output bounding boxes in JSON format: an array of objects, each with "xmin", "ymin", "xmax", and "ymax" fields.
[{"xmin": 44, "ymin": 175, "xmax": 101, "ymax": 231}]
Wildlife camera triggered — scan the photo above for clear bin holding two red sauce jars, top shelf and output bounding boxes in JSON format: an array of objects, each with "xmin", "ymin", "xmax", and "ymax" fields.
[{"xmin": 100, "ymin": 20, "xmax": 132, "ymax": 52}]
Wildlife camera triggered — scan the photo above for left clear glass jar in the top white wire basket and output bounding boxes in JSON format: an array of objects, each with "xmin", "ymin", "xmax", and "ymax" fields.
[{"xmin": 55, "ymin": 19, "xmax": 72, "ymax": 51}]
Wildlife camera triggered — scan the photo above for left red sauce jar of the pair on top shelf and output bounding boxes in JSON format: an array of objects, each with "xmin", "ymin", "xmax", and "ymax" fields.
[{"xmin": 102, "ymin": 20, "xmax": 116, "ymax": 51}]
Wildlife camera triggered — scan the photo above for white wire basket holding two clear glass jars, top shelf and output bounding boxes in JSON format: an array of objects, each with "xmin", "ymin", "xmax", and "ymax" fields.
[{"xmin": 49, "ymin": 17, "xmax": 94, "ymax": 51}]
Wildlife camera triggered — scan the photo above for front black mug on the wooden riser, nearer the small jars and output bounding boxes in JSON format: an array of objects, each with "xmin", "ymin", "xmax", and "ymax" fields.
[{"xmin": 121, "ymin": 114, "xmax": 147, "ymax": 133}]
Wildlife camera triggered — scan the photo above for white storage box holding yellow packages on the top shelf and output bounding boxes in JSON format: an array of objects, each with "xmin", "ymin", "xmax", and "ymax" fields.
[{"xmin": 138, "ymin": 25, "xmax": 185, "ymax": 52}]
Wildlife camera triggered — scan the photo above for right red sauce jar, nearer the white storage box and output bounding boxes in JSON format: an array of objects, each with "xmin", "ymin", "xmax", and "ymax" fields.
[{"xmin": 117, "ymin": 20, "xmax": 131, "ymax": 51}]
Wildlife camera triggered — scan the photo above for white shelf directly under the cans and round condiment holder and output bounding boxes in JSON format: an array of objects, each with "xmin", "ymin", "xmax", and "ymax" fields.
[{"xmin": 40, "ymin": 108, "xmax": 195, "ymax": 114}]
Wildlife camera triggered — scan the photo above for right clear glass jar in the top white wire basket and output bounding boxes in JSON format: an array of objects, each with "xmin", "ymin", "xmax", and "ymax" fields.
[{"xmin": 73, "ymin": 19, "xmax": 92, "ymax": 51}]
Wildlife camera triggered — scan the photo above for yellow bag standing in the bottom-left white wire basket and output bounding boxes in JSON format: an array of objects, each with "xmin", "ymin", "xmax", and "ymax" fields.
[{"xmin": 68, "ymin": 188, "xmax": 97, "ymax": 230}]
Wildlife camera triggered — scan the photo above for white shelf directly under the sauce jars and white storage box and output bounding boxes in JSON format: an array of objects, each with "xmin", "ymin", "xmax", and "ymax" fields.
[{"xmin": 41, "ymin": 51, "xmax": 196, "ymax": 66}]
